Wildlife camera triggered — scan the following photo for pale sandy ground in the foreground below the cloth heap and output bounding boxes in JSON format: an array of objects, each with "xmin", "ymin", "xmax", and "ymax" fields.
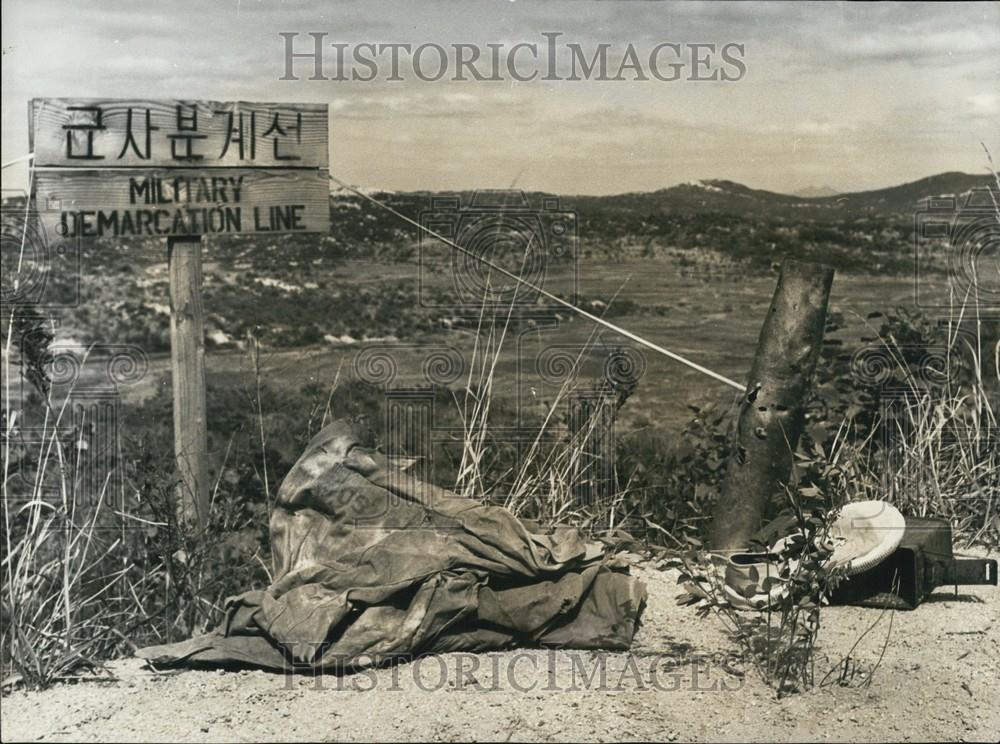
[{"xmin": 0, "ymin": 567, "xmax": 1000, "ymax": 741}]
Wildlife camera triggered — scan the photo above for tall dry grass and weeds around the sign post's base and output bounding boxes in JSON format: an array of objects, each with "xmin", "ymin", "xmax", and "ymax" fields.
[{"xmin": 0, "ymin": 316, "xmax": 269, "ymax": 689}]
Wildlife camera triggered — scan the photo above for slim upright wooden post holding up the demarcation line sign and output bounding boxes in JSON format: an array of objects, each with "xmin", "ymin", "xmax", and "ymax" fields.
[{"xmin": 167, "ymin": 236, "xmax": 209, "ymax": 531}]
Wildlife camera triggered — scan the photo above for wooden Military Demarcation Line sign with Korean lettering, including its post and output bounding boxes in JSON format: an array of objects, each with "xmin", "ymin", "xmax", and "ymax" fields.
[{"xmin": 29, "ymin": 98, "xmax": 330, "ymax": 527}]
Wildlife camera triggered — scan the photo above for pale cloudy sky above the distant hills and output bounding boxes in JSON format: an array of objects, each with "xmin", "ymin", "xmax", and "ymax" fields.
[{"xmin": 2, "ymin": 0, "xmax": 1000, "ymax": 194}]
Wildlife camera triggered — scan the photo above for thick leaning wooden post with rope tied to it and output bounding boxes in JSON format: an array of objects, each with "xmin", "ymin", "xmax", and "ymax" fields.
[{"xmin": 710, "ymin": 261, "xmax": 833, "ymax": 551}]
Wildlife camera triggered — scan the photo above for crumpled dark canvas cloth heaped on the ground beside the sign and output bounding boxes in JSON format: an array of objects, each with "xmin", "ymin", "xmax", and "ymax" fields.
[{"xmin": 138, "ymin": 421, "xmax": 646, "ymax": 670}]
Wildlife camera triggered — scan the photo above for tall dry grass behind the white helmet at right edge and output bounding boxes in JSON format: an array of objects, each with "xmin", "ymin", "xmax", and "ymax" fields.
[{"xmin": 829, "ymin": 166, "xmax": 1000, "ymax": 548}]
